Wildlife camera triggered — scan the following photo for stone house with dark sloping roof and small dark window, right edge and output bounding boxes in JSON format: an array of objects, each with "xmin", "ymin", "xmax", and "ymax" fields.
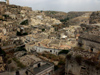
[{"xmin": 78, "ymin": 33, "xmax": 100, "ymax": 53}]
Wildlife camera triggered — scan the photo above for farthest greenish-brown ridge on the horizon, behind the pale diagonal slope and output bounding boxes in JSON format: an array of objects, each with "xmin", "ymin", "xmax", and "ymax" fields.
[{"xmin": 43, "ymin": 11, "xmax": 86, "ymax": 21}]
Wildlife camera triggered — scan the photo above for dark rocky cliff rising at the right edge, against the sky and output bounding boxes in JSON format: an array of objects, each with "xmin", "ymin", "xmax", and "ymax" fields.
[{"xmin": 89, "ymin": 11, "xmax": 100, "ymax": 24}]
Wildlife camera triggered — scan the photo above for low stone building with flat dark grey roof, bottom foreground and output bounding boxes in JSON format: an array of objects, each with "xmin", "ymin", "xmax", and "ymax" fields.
[{"xmin": 28, "ymin": 61, "xmax": 54, "ymax": 75}]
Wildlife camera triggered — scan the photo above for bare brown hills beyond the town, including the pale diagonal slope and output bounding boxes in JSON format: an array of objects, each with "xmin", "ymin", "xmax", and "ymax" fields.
[{"xmin": 43, "ymin": 11, "xmax": 91, "ymax": 26}]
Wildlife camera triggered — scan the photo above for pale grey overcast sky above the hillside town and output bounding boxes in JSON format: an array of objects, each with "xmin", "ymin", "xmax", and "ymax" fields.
[{"xmin": 0, "ymin": 0, "xmax": 100, "ymax": 12}]
